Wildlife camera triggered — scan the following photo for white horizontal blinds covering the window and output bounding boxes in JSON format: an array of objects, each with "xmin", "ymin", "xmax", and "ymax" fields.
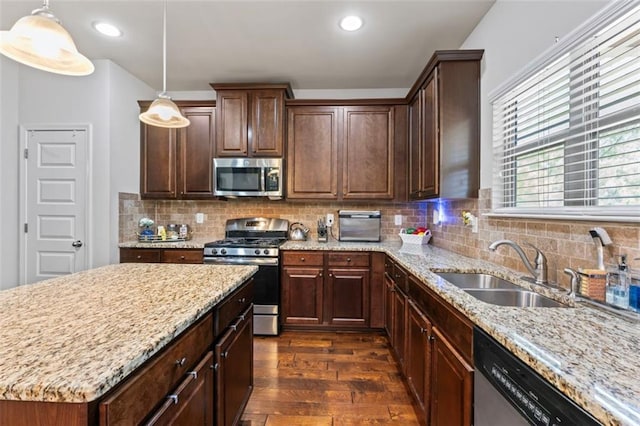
[{"xmin": 493, "ymin": 2, "xmax": 640, "ymax": 216}]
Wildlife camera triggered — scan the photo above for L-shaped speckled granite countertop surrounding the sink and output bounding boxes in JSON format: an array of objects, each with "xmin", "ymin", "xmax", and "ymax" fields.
[{"xmin": 281, "ymin": 241, "xmax": 640, "ymax": 425}]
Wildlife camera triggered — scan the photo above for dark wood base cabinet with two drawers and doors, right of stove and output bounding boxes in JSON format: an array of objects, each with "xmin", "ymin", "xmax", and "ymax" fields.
[{"xmin": 281, "ymin": 251, "xmax": 372, "ymax": 329}]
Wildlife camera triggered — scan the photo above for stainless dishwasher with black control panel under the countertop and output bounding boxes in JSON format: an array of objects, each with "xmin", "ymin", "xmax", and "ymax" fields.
[{"xmin": 473, "ymin": 327, "xmax": 601, "ymax": 426}]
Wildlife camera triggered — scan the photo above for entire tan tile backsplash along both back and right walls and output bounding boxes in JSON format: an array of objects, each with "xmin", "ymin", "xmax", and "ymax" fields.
[{"xmin": 119, "ymin": 189, "xmax": 640, "ymax": 286}]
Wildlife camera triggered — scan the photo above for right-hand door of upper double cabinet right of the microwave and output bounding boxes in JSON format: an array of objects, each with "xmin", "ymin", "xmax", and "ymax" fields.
[{"xmin": 342, "ymin": 106, "xmax": 394, "ymax": 200}]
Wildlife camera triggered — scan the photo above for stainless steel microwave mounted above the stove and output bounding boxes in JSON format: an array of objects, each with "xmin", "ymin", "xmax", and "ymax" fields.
[{"xmin": 213, "ymin": 158, "xmax": 282, "ymax": 200}]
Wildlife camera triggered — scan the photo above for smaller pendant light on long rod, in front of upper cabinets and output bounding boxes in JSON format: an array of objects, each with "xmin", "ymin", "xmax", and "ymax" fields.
[{"xmin": 139, "ymin": 0, "xmax": 191, "ymax": 129}]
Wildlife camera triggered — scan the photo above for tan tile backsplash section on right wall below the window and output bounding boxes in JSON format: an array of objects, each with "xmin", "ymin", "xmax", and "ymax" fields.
[{"xmin": 427, "ymin": 189, "xmax": 640, "ymax": 287}]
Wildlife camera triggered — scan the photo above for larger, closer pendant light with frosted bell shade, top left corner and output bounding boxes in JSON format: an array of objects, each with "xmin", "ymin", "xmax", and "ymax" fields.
[{"xmin": 0, "ymin": 0, "xmax": 95, "ymax": 76}]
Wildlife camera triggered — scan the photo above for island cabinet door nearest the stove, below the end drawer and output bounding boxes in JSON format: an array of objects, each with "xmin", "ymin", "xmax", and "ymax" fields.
[{"xmin": 215, "ymin": 306, "xmax": 253, "ymax": 426}]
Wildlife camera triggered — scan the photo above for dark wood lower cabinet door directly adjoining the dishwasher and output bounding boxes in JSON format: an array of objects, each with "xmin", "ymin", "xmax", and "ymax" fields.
[{"xmin": 429, "ymin": 327, "xmax": 473, "ymax": 426}]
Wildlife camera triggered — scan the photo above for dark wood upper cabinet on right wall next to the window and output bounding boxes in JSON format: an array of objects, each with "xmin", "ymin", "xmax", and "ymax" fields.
[{"xmin": 407, "ymin": 50, "xmax": 483, "ymax": 200}]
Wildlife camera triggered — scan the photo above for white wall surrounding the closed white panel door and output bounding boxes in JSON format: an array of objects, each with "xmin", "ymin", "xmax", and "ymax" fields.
[{"xmin": 0, "ymin": 57, "xmax": 155, "ymax": 288}]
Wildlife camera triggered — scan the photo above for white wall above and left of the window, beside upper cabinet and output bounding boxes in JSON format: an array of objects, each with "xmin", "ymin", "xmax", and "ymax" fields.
[{"xmin": 460, "ymin": 0, "xmax": 608, "ymax": 188}]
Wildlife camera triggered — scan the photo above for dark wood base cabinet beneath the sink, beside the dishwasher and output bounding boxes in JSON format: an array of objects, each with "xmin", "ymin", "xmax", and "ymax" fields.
[{"xmin": 385, "ymin": 258, "xmax": 473, "ymax": 426}]
